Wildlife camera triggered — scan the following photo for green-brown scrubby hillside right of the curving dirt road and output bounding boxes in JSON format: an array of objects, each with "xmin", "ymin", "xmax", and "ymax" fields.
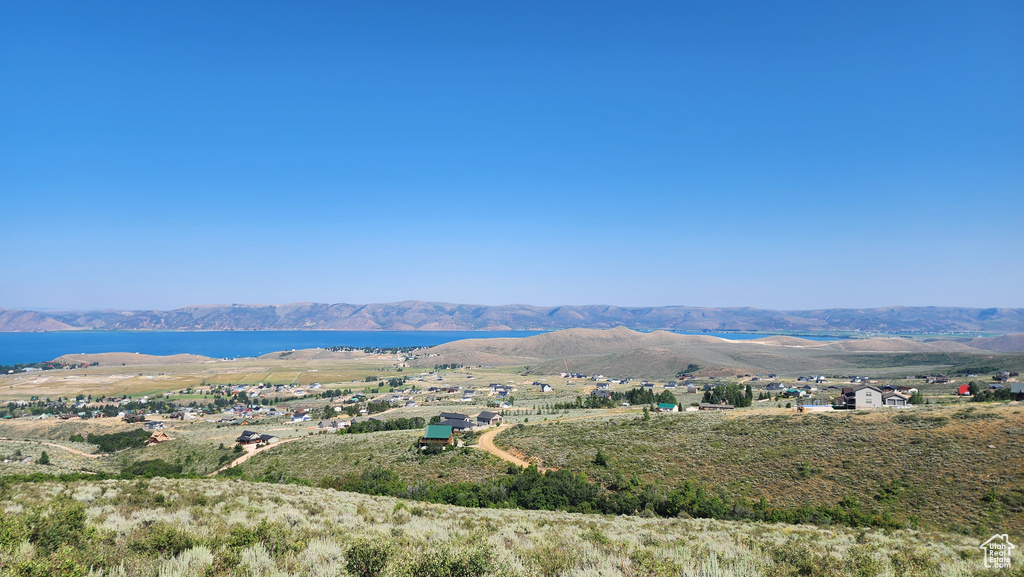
[{"xmin": 496, "ymin": 405, "xmax": 1024, "ymax": 535}]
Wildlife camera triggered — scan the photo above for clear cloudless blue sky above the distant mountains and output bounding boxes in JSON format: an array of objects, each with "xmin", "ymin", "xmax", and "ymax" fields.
[{"xmin": 0, "ymin": 0, "xmax": 1024, "ymax": 308}]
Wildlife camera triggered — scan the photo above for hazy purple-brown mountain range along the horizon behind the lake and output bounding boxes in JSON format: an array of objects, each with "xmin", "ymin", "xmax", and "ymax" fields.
[{"xmin": 0, "ymin": 300, "xmax": 1024, "ymax": 333}]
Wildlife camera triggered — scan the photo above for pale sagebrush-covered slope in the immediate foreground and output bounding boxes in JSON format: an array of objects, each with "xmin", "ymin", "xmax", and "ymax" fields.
[{"xmin": 0, "ymin": 479, "xmax": 999, "ymax": 577}]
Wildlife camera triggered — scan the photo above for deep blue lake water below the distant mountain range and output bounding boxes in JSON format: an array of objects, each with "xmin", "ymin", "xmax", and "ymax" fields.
[{"xmin": 0, "ymin": 331, "xmax": 834, "ymax": 365}]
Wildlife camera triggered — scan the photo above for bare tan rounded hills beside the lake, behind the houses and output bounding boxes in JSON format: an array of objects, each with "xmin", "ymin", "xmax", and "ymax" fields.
[{"xmin": 415, "ymin": 327, "xmax": 1024, "ymax": 378}]
